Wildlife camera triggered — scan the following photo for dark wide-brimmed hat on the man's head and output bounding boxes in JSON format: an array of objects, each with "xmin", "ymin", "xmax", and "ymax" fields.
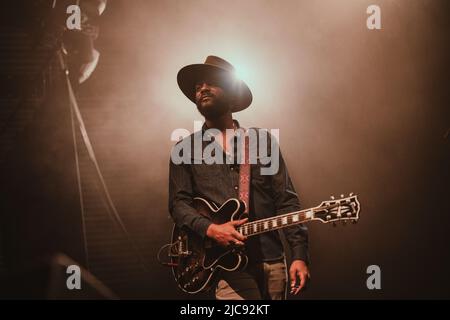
[{"xmin": 177, "ymin": 56, "xmax": 253, "ymax": 112}]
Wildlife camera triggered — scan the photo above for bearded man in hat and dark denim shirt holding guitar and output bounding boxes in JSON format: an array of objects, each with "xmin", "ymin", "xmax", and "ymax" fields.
[{"xmin": 169, "ymin": 56, "xmax": 309, "ymax": 299}]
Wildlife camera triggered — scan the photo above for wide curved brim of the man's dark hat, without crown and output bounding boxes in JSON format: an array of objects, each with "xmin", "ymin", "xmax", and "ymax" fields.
[{"xmin": 177, "ymin": 64, "xmax": 253, "ymax": 112}]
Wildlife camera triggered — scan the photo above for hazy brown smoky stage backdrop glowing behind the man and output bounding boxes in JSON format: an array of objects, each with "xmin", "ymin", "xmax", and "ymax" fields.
[{"xmin": 0, "ymin": 0, "xmax": 450, "ymax": 299}]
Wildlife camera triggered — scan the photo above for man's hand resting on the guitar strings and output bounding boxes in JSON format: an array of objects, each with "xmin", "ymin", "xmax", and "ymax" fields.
[{"xmin": 206, "ymin": 218, "xmax": 248, "ymax": 247}]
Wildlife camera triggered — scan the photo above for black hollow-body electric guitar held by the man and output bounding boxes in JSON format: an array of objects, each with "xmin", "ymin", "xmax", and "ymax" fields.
[{"xmin": 166, "ymin": 194, "xmax": 361, "ymax": 294}]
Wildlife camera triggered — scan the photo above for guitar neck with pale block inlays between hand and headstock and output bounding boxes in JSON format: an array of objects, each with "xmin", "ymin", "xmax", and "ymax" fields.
[{"xmin": 237, "ymin": 208, "xmax": 322, "ymax": 237}]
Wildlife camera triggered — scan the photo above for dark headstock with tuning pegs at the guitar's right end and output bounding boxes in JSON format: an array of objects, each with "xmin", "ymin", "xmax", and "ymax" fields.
[{"xmin": 314, "ymin": 193, "xmax": 361, "ymax": 223}]
